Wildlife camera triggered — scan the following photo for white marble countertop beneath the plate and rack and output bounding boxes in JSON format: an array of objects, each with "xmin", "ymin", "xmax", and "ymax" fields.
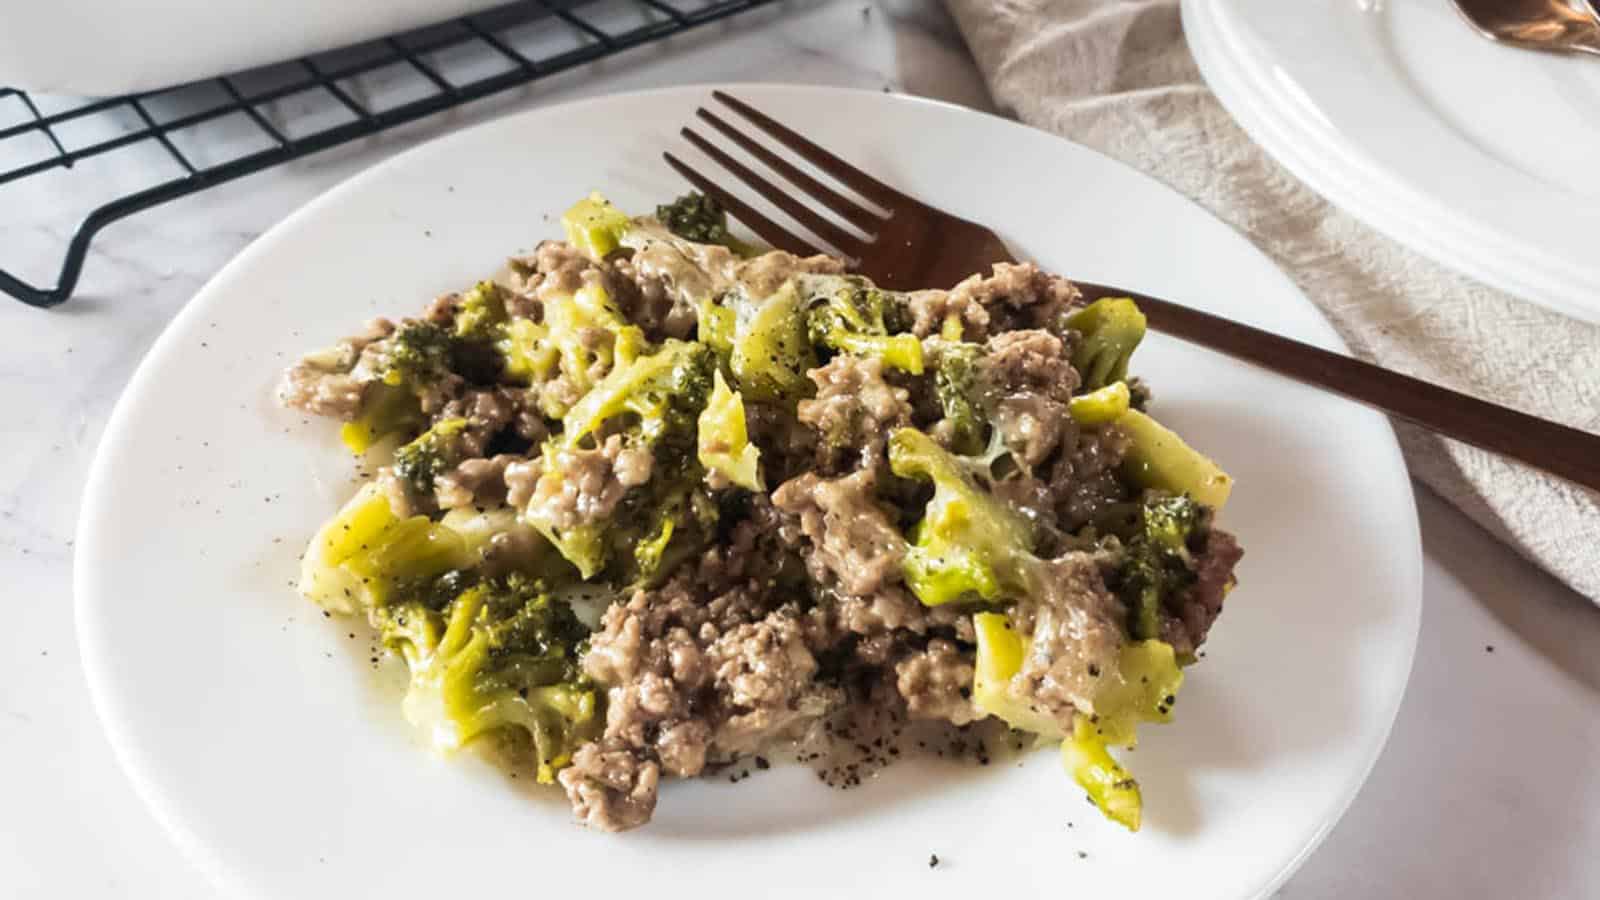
[{"xmin": 0, "ymin": 0, "xmax": 1600, "ymax": 900}]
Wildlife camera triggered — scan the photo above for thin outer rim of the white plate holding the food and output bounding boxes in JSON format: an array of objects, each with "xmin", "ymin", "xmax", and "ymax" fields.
[{"xmin": 72, "ymin": 82, "xmax": 1424, "ymax": 898}]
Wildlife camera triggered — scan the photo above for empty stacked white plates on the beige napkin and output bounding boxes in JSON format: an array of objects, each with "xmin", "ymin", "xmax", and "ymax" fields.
[{"xmin": 1182, "ymin": 0, "xmax": 1600, "ymax": 322}]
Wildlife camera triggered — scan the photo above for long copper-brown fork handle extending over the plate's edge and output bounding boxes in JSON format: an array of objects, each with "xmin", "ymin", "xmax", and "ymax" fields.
[{"xmin": 1074, "ymin": 280, "xmax": 1600, "ymax": 490}]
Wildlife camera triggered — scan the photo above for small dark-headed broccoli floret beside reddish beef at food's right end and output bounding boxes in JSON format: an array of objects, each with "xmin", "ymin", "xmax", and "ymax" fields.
[{"xmin": 1118, "ymin": 492, "xmax": 1211, "ymax": 641}]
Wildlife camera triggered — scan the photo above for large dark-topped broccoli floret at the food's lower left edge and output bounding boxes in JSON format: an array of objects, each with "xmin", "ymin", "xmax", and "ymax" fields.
[{"xmin": 373, "ymin": 573, "xmax": 602, "ymax": 783}]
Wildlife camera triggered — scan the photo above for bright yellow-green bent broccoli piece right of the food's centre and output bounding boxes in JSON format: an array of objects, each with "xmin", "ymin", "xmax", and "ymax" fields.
[{"xmin": 890, "ymin": 428, "xmax": 1037, "ymax": 607}]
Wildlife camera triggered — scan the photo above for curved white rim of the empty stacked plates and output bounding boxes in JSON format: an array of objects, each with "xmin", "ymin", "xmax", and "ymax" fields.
[{"xmin": 1179, "ymin": 0, "xmax": 1600, "ymax": 322}]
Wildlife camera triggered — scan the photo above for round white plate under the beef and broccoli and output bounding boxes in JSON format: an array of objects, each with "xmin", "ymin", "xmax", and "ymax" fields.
[{"xmin": 77, "ymin": 85, "xmax": 1421, "ymax": 900}]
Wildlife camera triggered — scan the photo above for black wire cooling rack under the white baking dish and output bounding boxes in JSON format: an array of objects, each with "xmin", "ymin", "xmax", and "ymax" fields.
[{"xmin": 0, "ymin": 0, "xmax": 776, "ymax": 307}]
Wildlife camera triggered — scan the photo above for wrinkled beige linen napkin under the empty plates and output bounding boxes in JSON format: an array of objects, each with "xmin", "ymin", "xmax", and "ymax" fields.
[{"xmin": 946, "ymin": 0, "xmax": 1600, "ymax": 602}]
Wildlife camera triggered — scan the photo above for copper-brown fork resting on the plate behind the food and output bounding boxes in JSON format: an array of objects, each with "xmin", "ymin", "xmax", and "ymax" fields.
[{"xmin": 662, "ymin": 91, "xmax": 1600, "ymax": 490}]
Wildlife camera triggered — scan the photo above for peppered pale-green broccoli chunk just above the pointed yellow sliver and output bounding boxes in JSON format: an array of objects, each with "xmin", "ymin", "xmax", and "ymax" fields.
[{"xmin": 728, "ymin": 282, "xmax": 816, "ymax": 404}]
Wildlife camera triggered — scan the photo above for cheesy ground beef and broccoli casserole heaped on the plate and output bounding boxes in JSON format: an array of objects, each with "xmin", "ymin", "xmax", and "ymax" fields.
[{"xmin": 282, "ymin": 195, "xmax": 1242, "ymax": 830}]
